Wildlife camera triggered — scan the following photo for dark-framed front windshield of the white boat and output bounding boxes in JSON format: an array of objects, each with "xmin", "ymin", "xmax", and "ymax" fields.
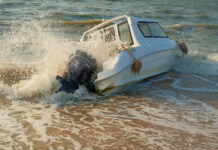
[{"xmin": 138, "ymin": 22, "xmax": 167, "ymax": 37}]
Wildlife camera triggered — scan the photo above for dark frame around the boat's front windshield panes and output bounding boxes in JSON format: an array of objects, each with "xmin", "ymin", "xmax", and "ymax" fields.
[{"xmin": 137, "ymin": 21, "xmax": 168, "ymax": 38}]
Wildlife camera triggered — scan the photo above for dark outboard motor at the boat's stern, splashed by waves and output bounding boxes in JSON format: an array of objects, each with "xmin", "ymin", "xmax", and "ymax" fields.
[{"xmin": 56, "ymin": 50, "xmax": 97, "ymax": 93}]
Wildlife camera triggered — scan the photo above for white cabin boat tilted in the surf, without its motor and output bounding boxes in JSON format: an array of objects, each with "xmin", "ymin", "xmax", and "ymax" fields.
[{"xmin": 81, "ymin": 15, "xmax": 185, "ymax": 94}]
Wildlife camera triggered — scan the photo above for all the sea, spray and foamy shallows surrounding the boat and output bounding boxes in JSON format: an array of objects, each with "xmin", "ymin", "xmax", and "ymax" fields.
[{"xmin": 0, "ymin": 0, "xmax": 218, "ymax": 150}]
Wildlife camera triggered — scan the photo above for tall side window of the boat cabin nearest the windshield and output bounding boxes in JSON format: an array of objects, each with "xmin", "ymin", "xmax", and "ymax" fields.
[{"xmin": 118, "ymin": 21, "xmax": 133, "ymax": 45}]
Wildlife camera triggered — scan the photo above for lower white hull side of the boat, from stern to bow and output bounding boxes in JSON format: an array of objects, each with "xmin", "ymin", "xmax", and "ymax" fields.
[{"xmin": 95, "ymin": 49, "xmax": 176, "ymax": 93}]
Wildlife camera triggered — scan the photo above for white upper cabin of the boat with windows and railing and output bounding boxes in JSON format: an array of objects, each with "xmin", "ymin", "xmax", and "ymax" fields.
[{"xmin": 81, "ymin": 15, "xmax": 167, "ymax": 47}]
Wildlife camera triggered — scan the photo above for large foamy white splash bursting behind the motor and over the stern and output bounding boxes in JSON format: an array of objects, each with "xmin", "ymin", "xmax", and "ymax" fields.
[{"xmin": 0, "ymin": 22, "xmax": 122, "ymax": 102}]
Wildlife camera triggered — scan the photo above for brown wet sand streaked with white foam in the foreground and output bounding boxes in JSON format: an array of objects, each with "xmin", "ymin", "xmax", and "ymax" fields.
[{"xmin": 0, "ymin": 88, "xmax": 218, "ymax": 150}]
